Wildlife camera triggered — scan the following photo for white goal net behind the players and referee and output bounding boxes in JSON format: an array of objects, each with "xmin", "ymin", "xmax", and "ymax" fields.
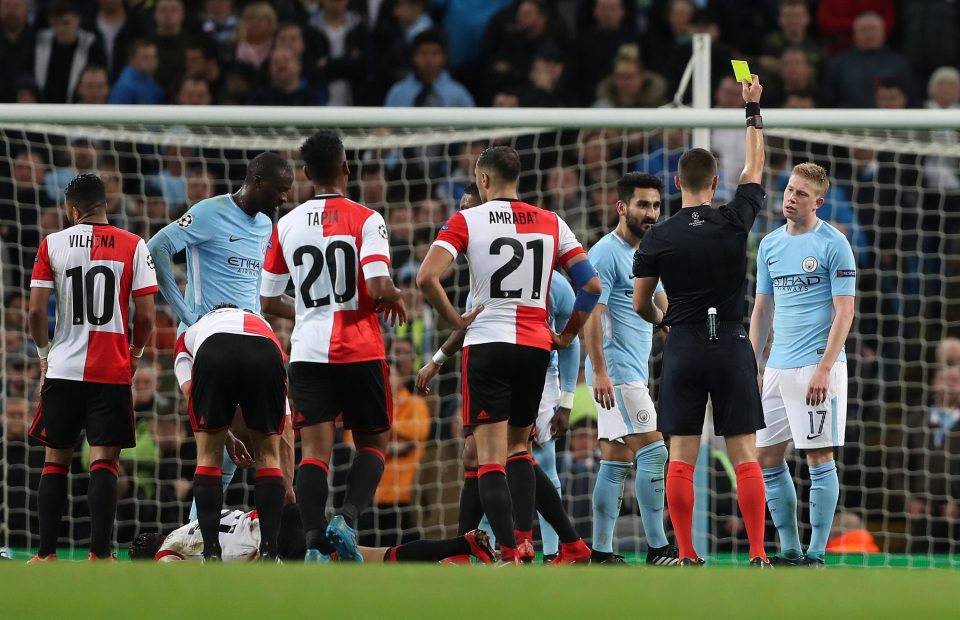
[{"xmin": 0, "ymin": 108, "xmax": 960, "ymax": 566}]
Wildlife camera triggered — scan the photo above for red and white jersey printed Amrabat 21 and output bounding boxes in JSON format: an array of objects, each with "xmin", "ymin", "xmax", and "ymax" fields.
[{"xmin": 434, "ymin": 200, "xmax": 583, "ymax": 350}]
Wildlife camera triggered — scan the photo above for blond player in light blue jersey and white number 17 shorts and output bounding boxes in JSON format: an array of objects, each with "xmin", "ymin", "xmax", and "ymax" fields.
[{"xmin": 750, "ymin": 163, "xmax": 857, "ymax": 567}]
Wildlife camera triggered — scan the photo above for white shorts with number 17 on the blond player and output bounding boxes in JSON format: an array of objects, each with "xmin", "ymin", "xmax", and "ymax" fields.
[{"xmin": 757, "ymin": 362, "xmax": 847, "ymax": 450}]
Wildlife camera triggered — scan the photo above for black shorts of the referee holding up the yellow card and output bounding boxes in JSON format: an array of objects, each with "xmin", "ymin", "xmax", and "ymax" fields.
[{"xmin": 657, "ymin": 323, "xmax": 765, "ymax": 436}]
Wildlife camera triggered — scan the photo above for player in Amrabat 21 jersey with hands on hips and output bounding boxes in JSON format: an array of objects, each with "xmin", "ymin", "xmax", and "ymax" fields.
[{"xmin": 417, "ymin": 146, "xmax": 600, "ymax": 563}]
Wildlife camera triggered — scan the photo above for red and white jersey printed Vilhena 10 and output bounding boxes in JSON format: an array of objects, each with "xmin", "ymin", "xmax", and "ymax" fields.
[{"xmin": 30, "ymin": 224, "xmax": 157, "ymax": 385}]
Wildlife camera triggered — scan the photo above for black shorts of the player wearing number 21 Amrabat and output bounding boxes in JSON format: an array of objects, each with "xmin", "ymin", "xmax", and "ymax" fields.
[{"xmin": 460, "ymin": 342, "xmax": 550, "ymax": 428}]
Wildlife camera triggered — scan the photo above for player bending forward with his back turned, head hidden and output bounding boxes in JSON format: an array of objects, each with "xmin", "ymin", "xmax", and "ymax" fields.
[{"xmin": 174, "ymin": 304, "xmax": 287, "ymax": 560}]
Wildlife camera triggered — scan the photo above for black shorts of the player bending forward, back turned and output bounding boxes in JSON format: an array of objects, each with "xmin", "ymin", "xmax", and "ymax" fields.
[{"xmin": 190, "ymin": 333, "xmax": 287, "ymax": 434}]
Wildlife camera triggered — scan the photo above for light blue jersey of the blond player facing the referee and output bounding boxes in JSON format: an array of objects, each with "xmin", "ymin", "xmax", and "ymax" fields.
[{"xmin": 757, "ymin": 220, "xmax": 857, "ymax": 368}]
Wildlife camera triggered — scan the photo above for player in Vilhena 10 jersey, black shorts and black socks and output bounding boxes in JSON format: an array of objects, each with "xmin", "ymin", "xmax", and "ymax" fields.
[{"xmin": 29, "ymin": 174, "xmax": 157, "ymax": 561}]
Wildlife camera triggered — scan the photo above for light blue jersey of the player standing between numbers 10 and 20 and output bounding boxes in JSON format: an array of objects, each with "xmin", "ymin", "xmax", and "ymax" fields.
[{"xmin": 147, "ymin": 194, "xmax": 273, "ymax": 333}]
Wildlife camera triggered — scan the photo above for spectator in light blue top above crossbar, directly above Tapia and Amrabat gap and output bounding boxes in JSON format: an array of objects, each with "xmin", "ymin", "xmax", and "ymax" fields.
[{"xmin": 384, "ymin": 30, "xmax": 474, "ymax": 108}]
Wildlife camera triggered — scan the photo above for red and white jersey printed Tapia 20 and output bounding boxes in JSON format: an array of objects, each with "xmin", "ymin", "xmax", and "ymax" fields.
[{"xmin": 260, "ymin": 195, "xmax": 390, "ymax": 364}]
